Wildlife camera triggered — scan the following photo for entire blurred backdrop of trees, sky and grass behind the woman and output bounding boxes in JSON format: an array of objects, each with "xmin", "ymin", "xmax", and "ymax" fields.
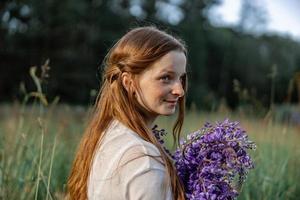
[{"xmin": 0, "ymin": 0, "xmax": 300, "ymax": 199}]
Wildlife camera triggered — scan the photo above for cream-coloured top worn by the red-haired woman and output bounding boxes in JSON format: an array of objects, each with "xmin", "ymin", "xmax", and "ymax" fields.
[{"xmin": 88, "ymin": 120, "xmax": 172, "ymax": 200}]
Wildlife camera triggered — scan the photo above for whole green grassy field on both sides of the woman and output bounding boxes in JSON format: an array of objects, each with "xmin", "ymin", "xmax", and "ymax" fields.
[{"xmin": 0, "ymin": 103, "xmax": 300, "ymax": 200}]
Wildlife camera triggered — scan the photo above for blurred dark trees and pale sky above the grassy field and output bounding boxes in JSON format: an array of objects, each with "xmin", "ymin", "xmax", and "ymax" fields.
[{"xmin": 0, "ymin": 0, "xmax": 300, "ymax": 110}]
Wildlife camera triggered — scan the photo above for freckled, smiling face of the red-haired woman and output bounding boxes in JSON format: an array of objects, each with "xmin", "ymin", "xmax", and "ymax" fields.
[{"xmin": 137, "ymin": 51, "xmax": 186, "ymax": 120}]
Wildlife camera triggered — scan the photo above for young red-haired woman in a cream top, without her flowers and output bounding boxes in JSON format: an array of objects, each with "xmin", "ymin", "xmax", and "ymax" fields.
[{"xmin": 68, "ymin": 27, "xmax": 186, "ymax": 200}]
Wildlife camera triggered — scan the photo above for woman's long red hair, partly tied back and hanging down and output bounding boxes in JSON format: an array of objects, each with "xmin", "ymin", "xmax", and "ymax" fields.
[{"xmin": 68, "ymin": 27, "xmax": 187, "ymax": 200}]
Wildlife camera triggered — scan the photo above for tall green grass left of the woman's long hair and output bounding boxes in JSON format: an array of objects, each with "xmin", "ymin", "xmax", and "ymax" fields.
[{"xmin": 0, "ymin": 105, "xmax": 85, "ymax": 199}]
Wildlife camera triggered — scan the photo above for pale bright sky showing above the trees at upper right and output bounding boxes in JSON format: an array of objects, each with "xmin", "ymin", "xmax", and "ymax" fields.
[{"xmin": 211, "ymin": 0, "xmax": 300, "ymax": 41}]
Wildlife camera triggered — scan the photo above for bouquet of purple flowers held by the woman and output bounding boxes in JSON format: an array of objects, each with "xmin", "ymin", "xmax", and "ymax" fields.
[{"xmin": 154, "ymin": 119, "xmax": 256, "ymax": 200}]
